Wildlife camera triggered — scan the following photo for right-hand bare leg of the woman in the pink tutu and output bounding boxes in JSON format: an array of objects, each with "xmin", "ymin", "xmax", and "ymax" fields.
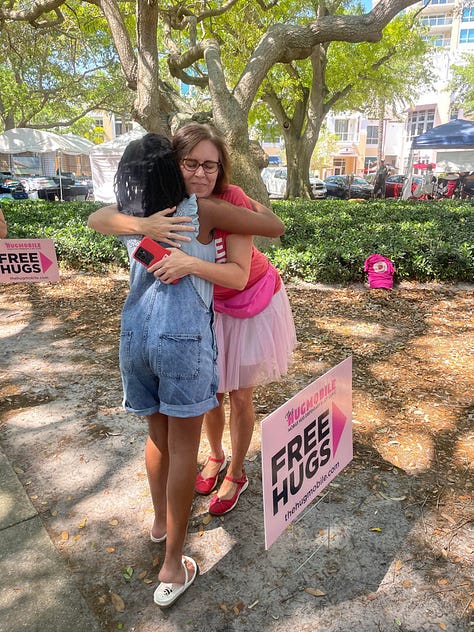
[{"xmin": 218, "ymin": 387, "xmax": 255, "ymax": 500}]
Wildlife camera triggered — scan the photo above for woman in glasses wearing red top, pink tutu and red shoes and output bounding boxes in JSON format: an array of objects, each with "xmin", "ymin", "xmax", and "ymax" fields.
[{"xmin": 153, "ymin": 124, "xmax": 296, "ymax": 515}]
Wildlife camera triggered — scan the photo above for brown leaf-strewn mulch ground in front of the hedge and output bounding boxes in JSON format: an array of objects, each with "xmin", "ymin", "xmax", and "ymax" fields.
[{"xmin": 0, "ymin": 274, "xmax": 474, "ymax": 629}]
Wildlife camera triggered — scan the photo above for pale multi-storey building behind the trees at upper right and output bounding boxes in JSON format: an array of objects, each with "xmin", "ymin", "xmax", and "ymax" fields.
[{"xmin": 326, "ymin": 0, "xmax": 474, "ymax": 175}]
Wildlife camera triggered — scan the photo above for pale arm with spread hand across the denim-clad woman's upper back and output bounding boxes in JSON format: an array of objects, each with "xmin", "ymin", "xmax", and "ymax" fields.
[{"xmin": 87, "ymin": 204, "xmax": 194, "ymax": 248}]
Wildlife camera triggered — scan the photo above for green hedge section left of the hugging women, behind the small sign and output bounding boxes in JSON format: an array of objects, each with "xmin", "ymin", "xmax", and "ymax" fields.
[{"xmin": 2, "ymin": 199, "xmax": 128, "ymax": 272}]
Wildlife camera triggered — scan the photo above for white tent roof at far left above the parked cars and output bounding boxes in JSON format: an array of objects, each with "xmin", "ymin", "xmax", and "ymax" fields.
[{"xmin": 0, "ymin": 127, "xmax": 94, "ymax": 156}]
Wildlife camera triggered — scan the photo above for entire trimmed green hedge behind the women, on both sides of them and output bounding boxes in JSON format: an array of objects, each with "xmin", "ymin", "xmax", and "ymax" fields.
[{"xmin": 1, "ymin": 199, "xmax": 474, "ymax": 283}]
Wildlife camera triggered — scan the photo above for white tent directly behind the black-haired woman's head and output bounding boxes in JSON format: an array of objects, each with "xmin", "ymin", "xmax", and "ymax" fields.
[{"xmin": 89, "ymin": 127, "xmax": 146, "ymax": 204}]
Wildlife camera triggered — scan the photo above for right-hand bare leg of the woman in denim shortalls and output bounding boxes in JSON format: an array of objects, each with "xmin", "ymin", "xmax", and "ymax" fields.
[{"xmin": 158, "ymin": 415, "xmax": 203, "ymax": 584}]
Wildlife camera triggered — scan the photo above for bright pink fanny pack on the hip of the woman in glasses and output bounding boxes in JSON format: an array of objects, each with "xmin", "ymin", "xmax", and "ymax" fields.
[{"xmin": 214, "ymin": 264, "xmax": 278, "ymax": 318}]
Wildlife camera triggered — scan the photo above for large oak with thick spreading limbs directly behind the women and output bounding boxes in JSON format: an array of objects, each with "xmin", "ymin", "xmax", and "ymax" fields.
[{"xmin": 0, "ymin": 0, "xmax": 426, "ymax": 197}]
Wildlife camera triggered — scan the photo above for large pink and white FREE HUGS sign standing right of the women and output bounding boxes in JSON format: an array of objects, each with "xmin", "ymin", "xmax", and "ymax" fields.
[{"xmin": 261, "ymin": 357, "xmax": 353, "ymax": 549}]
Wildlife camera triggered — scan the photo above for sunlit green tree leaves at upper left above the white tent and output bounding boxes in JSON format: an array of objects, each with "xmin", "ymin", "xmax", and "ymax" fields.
[{"xmin": 0, "ymin": 4, "xmax": 131, "ymax": 134}]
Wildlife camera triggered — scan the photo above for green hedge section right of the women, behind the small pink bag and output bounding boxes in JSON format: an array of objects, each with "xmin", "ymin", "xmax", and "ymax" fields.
[{"xmin": 269, "ymin": 200, "xmax": 474, "ymax": 283}]
